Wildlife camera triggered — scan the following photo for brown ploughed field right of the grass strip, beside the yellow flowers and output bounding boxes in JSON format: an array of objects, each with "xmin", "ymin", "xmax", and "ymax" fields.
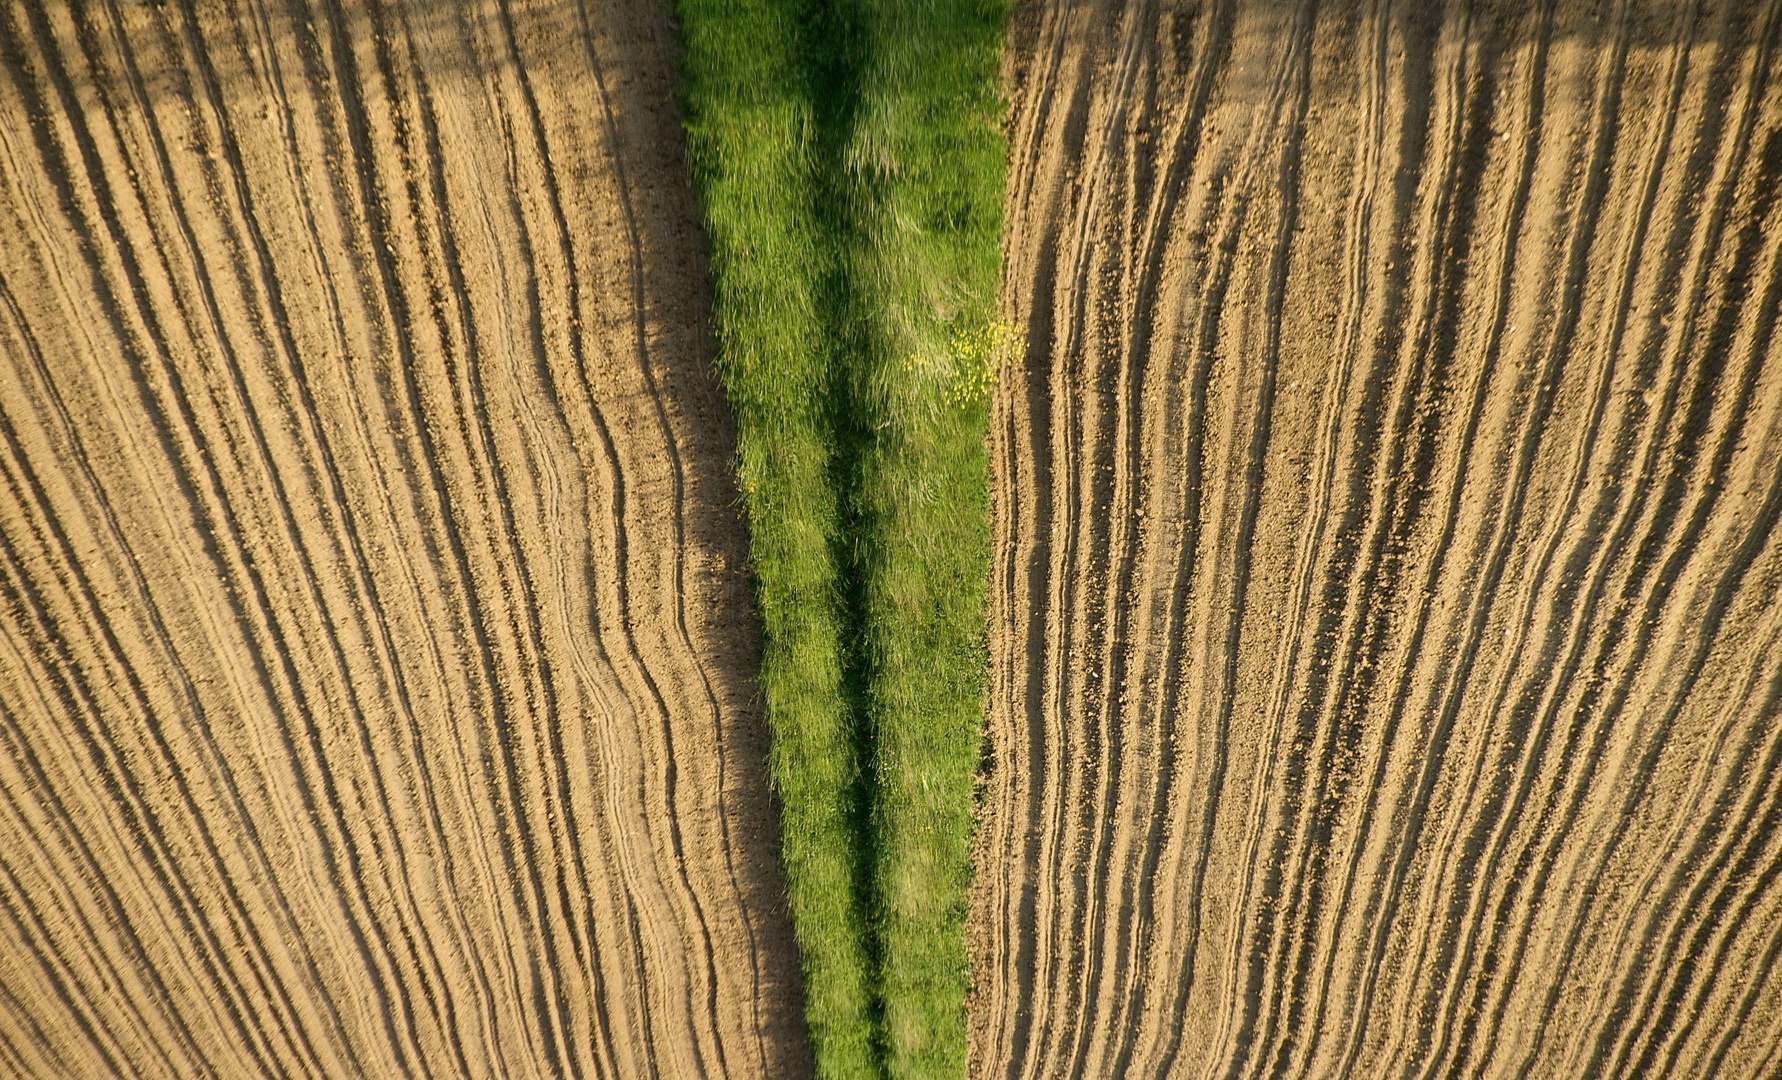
[{"xmin": 973, "ymin": 0, "xmax": 1782, "ymax": 1080}]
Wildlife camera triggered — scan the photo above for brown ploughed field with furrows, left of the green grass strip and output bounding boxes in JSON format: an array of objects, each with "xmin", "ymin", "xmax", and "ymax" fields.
[{"xmin": 0, "ymin": 0, "xmax": 809, "ymax": 1080}]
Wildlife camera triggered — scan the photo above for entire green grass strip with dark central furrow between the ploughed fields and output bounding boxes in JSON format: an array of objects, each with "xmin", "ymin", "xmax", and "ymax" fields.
[{"xmin": 681, "ymin": 0, "xmax": 1019, "ymax": 1080}]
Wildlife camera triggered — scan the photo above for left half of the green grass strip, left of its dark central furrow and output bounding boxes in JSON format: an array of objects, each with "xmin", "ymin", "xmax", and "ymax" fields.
[{"xmin": 681, "ymin": 0, "xmax": 879, "ymax": 1080}]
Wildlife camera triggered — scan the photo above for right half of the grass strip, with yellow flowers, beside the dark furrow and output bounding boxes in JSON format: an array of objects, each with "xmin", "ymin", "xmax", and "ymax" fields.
[{"xmin": 841, "ymin": 0, "xmax": 1014, "ymax": 1080}]
